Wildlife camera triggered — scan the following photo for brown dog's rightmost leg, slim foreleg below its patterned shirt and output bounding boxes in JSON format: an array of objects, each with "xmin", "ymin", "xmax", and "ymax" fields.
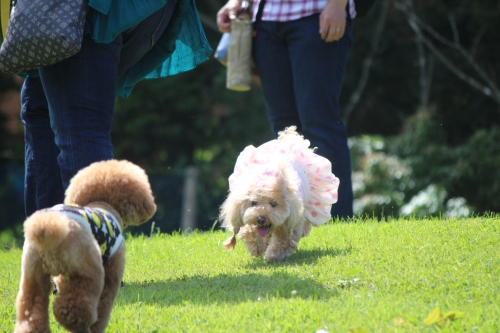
[{"xmin": 90, "ymin": 243, "xmax": 125, "ymax": 333}]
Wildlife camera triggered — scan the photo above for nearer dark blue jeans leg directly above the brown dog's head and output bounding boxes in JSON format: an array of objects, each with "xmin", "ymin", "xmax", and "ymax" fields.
[{"xmin": 39, "ymin": 38, "xmax": 120, "ymax": 189}]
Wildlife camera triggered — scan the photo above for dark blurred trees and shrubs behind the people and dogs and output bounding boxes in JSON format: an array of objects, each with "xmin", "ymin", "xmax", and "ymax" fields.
[{"xmin": 0, "ymin": 0, "xmax": 500, "ymax": 244}]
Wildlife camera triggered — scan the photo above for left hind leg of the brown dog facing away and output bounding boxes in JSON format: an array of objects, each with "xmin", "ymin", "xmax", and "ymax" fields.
[{"xmin": 14, "ymin": 245, "xmax": 52, "ymax": 333}]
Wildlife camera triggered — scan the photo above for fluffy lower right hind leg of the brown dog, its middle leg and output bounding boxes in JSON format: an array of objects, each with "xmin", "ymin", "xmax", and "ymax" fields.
[{"xmin": 54, "ymin": 265, "xmax": 104, "ymax": 333}]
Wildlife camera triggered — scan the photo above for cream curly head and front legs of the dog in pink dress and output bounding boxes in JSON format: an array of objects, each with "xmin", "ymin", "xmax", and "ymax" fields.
[{"xmin": 220, "ymin": 160, "xmax": 311, "ymax": 261}]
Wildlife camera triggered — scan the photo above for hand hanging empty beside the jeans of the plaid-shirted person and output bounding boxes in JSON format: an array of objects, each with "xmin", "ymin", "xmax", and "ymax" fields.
[{"xmin": 319, "ymin": 0, "xmax": 347, "ymax": 43}]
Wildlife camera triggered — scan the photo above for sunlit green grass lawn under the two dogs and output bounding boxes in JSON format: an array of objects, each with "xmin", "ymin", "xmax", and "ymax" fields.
[{"xmin": 0, "ymin": 216, "xmax": 500, "ymax": 333}]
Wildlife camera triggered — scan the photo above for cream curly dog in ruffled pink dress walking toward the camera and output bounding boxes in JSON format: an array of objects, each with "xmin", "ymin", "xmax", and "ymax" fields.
[{"xmin": 220, "ymin": 126, "xmax": 339, "ymax": 261}]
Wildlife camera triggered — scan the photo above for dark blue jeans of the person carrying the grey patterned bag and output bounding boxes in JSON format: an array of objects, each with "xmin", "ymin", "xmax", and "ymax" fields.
[{"xmin": 21, "ymin": 1, "xmax": 176, "ymax": 216}]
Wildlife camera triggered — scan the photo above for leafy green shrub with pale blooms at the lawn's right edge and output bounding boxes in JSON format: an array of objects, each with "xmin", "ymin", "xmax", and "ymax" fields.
[{"xmin": 350, "ymin": 110, "xmax": 500, "ymax": 217}]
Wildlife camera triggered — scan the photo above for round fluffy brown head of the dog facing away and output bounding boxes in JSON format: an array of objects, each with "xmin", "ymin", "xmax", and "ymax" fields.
[{"xmin": 64, "ymin": 160, "xmax": 156, "ymax": 225}]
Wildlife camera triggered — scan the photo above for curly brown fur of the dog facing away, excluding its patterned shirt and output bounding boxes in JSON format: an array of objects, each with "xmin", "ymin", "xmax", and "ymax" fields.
[{"xmin": 14, "ymin": 160, "xmax": 156, "ymax": 333}]
